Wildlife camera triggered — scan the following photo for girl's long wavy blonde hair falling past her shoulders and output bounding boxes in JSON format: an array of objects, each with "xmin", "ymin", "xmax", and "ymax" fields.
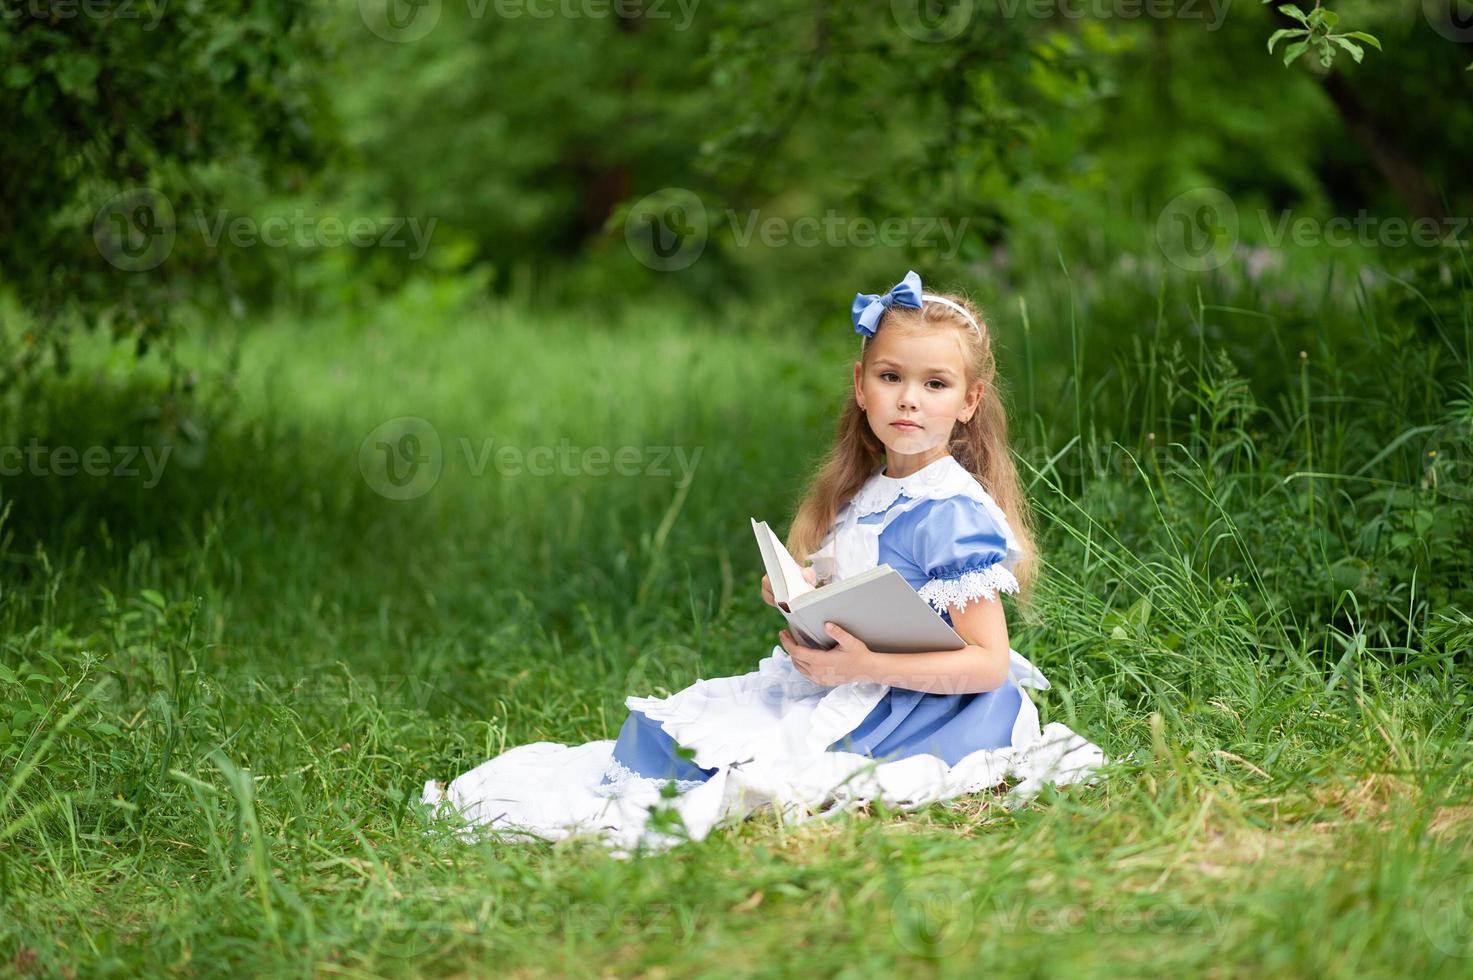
[{"xmin": 787, "ymin": 284, "xmax": 1038, "ymax": 597}]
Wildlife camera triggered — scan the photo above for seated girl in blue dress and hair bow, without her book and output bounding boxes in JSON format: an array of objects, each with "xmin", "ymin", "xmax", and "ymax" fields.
[{"xmin": 423, "ymin": 271, "xmax": 1105, "ymax": 853}]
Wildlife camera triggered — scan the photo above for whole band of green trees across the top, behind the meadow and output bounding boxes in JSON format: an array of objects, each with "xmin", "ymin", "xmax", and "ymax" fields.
[{"xmin": 0, "ymin": 0, "xmax": 1473, "ymax": 346}]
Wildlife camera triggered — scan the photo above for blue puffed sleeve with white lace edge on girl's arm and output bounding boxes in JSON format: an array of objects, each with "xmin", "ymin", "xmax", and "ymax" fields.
[{"xmin": 913, "ymin": 495, "xmax": 1022, "ymax": 613}]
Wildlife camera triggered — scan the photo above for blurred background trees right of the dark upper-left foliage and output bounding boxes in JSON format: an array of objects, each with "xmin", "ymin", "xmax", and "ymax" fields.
[{"xmin": 319, "ymin": 0, "xmax": 1473, "ymax": 310}]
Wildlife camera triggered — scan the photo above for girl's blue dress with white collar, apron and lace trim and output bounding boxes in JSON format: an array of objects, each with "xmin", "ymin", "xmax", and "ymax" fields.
[{"xmin": 423, "ymin": 455, "xmax": 1105, "ymax": 853}]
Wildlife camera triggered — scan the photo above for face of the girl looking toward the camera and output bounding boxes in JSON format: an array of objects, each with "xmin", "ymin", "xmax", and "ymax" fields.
[{"xmin": 854, "ymin": 329, "xmax": 982, "ymax": 477}]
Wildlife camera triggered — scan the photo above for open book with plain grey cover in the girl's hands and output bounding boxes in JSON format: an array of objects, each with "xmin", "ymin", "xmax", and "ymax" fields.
[{"xmin": 751, "ymin": 517, "xmax": 966, "ymax": 653}]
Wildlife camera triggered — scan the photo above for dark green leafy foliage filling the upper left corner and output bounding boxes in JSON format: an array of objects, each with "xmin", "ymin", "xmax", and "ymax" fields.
[{"xmin": 0, "ymin": 0, "xmax": 327, "ymax": 389}]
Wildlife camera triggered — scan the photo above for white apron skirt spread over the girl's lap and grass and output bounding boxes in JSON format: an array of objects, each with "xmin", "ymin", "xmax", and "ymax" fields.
[{"xmin": 421, "ymin": 647, "xmax": 1106, "ymax": 856}]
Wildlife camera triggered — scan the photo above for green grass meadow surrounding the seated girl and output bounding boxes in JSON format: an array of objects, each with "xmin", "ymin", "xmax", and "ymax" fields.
[{"xmin": 0, "ymin": 262, "xmax": 1473, "ymax": 977}]
